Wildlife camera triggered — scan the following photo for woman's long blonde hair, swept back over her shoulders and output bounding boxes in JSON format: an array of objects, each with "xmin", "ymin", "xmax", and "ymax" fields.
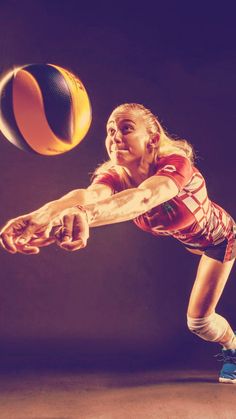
[{"xmin": 94, "ymin": 103, "xmax": 194, "ymax": 182}]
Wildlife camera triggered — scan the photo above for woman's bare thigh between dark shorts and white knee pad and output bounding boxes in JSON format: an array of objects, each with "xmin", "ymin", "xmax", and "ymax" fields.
[{"xmin": 188, "ymin": 255, "xmax": 234, "ymax": 317}]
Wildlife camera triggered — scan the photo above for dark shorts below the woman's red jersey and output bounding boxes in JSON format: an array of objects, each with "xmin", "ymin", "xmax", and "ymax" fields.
[{"xmin": 185, "ymin": 224, "xmax": 236, "ymax": 262}]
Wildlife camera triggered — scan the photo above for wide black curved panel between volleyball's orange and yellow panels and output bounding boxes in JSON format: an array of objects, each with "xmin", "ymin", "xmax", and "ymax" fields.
[{"xmin": 24, "ymin": 64, "xmax": 73, "ymax": 143}]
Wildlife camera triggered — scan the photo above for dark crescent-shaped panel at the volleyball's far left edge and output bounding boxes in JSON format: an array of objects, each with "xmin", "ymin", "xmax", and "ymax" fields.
[{"xmin": 0, "ymin": 75, "xmax": 35, "ymax": 154}]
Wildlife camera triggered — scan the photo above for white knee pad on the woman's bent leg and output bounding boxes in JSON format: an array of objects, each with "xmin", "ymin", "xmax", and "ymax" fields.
[{"xmin": 187, "ymin": 312, "xmax": 229, "ymax": 342}]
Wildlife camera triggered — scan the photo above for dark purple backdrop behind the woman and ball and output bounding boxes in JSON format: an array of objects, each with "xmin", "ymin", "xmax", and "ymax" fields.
[{"xmin": 0, "ymin": 0, "xmax": 236, "ymax": 367}]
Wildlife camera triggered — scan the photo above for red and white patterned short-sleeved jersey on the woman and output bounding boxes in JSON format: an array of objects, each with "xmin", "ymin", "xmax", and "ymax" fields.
[{"xmin": 93, "ymin": 154, "xmax": 234, "ymax": 250}]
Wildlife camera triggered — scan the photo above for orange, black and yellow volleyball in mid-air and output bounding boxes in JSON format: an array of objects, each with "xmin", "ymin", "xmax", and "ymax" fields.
[{"xmin": 0, "ymin": 64, "xmax": 92, "ymax": 156}]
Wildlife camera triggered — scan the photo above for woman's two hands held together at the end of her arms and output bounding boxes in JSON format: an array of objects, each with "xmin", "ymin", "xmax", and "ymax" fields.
[{"xmin": 0, "ymin": 207, "xmax": 89, "ymax": 254}]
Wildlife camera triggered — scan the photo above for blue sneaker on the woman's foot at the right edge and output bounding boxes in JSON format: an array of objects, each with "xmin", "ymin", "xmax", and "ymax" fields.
[{"xmin": 218, "ymin": 349, "xmax": 236, "ymax": 384}]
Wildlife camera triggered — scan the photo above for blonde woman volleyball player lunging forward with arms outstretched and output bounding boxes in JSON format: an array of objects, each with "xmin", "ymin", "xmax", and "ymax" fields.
[{"xmin": 1, "ymin": 104, "xmax": 236, "ymax": 383}]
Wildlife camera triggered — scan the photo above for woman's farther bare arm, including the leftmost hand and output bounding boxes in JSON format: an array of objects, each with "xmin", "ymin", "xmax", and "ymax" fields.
[{"xmin": 0, "ymin": 184, "xmax": 112, "ymax": 254}]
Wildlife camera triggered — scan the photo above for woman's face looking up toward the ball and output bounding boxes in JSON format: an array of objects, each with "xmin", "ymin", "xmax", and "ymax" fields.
[{"xmin": 105, "ymin": 111, "xmax": 150, "ymax": 166}]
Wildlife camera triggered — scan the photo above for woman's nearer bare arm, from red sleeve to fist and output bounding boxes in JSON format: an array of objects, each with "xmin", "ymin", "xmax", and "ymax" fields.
[{"xmin": 55, "ymin": 176, "xmax": 179, "ymax": 251}]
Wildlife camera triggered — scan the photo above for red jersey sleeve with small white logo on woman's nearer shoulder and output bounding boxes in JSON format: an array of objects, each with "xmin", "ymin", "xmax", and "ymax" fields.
[{"xmin": 155, "ymin": 154, "xmax": 193, "ymax": 191}]
